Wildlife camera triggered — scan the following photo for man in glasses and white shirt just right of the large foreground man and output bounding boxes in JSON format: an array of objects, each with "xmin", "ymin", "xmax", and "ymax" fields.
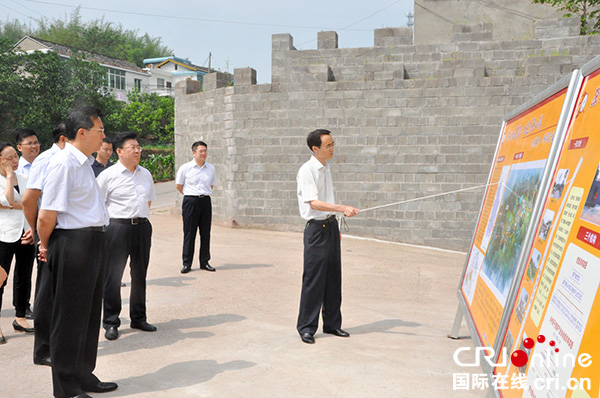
[{"xmin": 97, "ymin": 133, "xmax": 156, "ymax": 340}]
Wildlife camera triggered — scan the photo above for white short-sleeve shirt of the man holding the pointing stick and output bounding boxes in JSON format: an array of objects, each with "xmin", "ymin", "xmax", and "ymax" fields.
[{"xmin": 296, "ymin": 156, "xmax": 335, "ymax": 220}]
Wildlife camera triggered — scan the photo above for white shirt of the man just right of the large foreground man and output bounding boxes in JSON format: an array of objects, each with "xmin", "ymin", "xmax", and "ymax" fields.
[{"xmin": 96, "ymin": 161, "xmax": 156, "ymax": 218}]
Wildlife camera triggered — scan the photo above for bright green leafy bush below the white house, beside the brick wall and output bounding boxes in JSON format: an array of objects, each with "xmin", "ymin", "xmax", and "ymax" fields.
[{"xmin": 105, "ymin": 91, "xmax": 175, "ymax": 143}]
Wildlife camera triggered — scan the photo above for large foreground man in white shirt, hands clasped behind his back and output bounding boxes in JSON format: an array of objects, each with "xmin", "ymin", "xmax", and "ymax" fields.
[{"xmin": 37, "ymin": 107, "xmax": 118, "ymax": 398}]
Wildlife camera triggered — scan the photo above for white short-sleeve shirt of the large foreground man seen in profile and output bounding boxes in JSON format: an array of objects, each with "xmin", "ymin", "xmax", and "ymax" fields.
[{"xmin": 40, "ymin": 143, "xmax": 109, "ymax": 229}]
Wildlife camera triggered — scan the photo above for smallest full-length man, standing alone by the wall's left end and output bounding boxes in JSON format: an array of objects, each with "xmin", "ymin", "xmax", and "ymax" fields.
[{"xmin": 175, "ymin": 141, "xmax": 217, "ymax": 274}]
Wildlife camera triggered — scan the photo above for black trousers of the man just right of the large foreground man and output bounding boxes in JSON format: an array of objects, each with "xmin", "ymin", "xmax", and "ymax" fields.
[{"xmin": 102, "ymin": 220, "xmax": 152, "ymax": 329}]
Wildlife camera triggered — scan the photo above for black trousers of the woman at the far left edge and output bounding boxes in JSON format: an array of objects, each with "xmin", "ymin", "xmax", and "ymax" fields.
[{"xmin": 0, "ymin": 239, "xmax": 35, "ymax": 318}]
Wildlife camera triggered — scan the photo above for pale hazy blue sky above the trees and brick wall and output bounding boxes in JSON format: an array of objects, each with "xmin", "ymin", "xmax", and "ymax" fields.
[{"xmin": 0, "ymin": 0, "xmax": 414, "ymax": 84}]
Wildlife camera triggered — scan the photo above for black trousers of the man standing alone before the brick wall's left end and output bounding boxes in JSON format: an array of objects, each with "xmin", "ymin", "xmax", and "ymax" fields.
[{"xmin": 181, "ymin": 195, "xmax": 212, "ymax": 266}]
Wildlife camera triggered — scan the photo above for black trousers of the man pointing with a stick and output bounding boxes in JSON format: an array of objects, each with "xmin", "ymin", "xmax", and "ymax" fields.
[{"xmin": 296, "ymin": 218, "xmax": 342, "ymax": 335}]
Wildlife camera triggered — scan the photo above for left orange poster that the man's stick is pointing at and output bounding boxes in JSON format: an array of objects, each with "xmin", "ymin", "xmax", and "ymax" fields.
[{"xmin": 460, "ymin": 87, "xmax": 567, "ymax": 347}]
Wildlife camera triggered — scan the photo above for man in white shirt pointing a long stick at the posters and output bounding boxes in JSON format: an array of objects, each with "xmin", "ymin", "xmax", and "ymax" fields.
[{"xmin": 296, "ymin": 130, "xmax": 359, "ymax": 344}]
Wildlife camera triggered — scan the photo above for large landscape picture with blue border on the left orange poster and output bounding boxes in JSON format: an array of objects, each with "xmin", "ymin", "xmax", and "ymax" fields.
[{"xmin": 481, "ymin": 160, "xmax": 546, "ymax": 306}]
